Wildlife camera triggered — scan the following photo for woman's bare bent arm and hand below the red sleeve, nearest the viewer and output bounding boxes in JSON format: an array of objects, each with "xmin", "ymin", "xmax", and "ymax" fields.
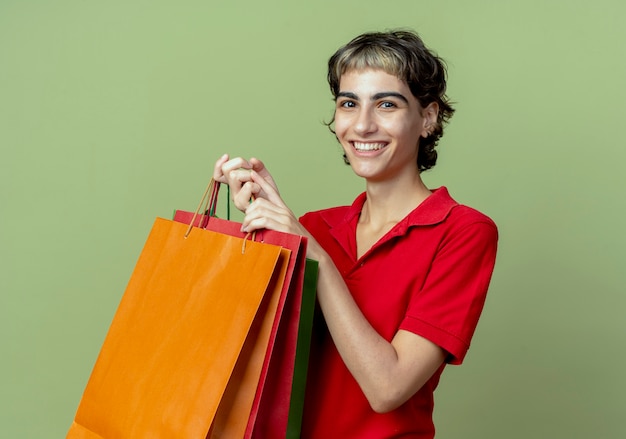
[{"xmin": 239, "ymin": 168, "xmax": 445, "ymax": 413}]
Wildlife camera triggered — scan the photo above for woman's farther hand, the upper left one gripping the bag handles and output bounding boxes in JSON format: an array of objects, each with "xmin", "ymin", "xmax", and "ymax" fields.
[{"xmin": 213, "ymin": 154, "xmax": 278, "ymax": 212}]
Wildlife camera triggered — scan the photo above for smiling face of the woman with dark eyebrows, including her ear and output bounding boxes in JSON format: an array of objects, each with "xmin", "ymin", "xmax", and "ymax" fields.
[{"xmin": 335, "ymin": 69, "xmax": 437, "ymax": 181}]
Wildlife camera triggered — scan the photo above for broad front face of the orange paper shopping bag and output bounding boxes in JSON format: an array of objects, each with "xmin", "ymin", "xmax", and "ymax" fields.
[{"xmin": 67, "ymin": 218, "xmax": 289, "ymax": 439}]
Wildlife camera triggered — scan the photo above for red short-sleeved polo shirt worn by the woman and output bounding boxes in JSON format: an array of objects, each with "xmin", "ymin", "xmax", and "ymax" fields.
[{"xmin": 300, "ymin": 187, "xmax": 498, "ymax": 439}]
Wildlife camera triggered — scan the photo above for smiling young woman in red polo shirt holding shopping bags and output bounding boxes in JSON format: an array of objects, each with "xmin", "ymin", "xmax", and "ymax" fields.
[{"xmin": 214, "ymin": 31, "xmax": 497, "ymax": 439}]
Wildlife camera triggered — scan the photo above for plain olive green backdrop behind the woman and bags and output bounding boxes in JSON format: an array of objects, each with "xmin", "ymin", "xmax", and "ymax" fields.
[{"xmin": 0, "ymin": 0, "xmax": 626, "ymax": 439}]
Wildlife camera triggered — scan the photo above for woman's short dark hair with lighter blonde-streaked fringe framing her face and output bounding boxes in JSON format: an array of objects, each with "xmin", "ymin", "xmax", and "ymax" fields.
[{"xmin": 328, "ymin": 30, "xmax": 454, "ymax": 171}]
